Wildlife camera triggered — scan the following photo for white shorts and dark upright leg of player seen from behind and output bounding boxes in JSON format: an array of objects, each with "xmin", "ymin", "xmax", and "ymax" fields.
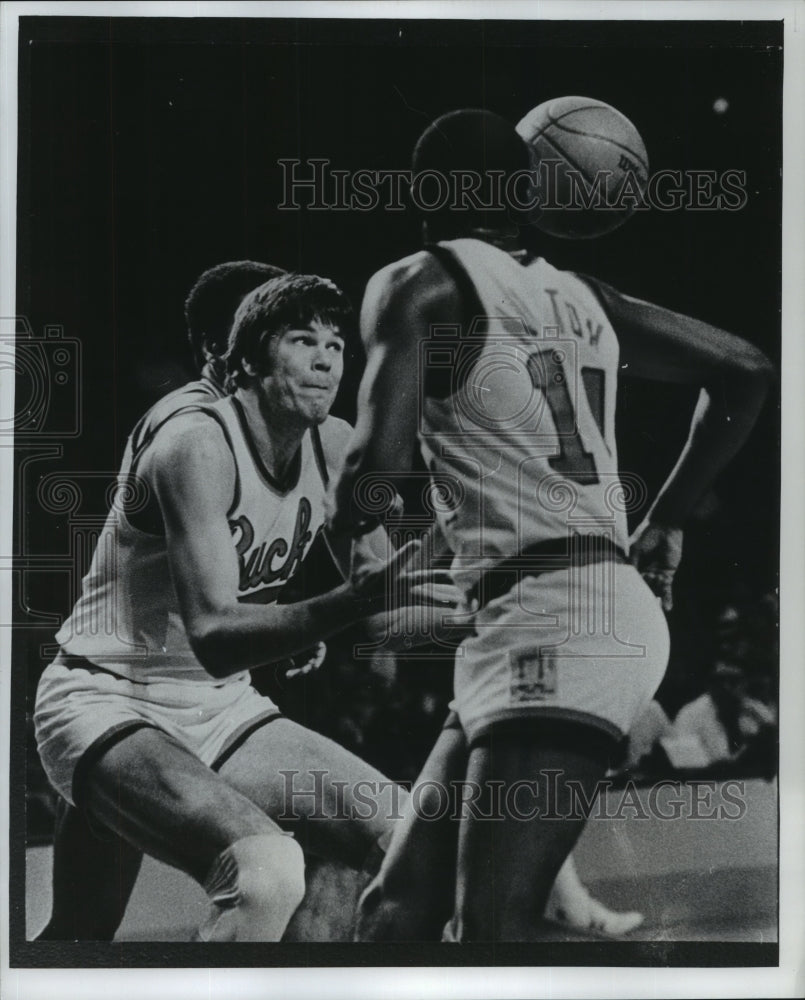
[{"xmin": 452, "ymin": 562, "xmax": 668, "ymax": 941}]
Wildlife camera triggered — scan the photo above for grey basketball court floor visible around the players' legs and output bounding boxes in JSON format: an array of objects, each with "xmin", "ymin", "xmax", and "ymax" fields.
[{"xmin": 26, "ymin": 779, "xmax": 778, "ymax": 944}]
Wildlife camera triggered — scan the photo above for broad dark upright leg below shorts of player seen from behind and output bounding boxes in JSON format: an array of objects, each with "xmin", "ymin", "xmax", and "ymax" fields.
[{"xmin": 448, "ymin": 724, "xmax": 608, "ymax": 941}]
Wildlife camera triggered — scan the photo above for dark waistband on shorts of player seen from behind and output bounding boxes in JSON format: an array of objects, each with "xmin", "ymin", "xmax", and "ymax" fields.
[{"xmin": 467, "ymin": 534, "xmax": 629, "ymax": 608}]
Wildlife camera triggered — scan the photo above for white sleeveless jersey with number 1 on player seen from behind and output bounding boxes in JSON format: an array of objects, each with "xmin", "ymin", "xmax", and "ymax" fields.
[{"xmin": 419, "ymin": 239, "xmax": 627, "ymax": 591}]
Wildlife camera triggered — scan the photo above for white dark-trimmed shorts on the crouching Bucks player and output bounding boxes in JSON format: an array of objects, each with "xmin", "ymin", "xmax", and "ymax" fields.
[{"xmin": 34, "ymin": 653, "xmax": 281, "ymax": 805}]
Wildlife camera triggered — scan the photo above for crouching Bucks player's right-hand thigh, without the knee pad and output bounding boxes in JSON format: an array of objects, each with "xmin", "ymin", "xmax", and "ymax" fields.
[{"xmin": 218, "ymin": 718, "xmax": 398, "ymax": 868}]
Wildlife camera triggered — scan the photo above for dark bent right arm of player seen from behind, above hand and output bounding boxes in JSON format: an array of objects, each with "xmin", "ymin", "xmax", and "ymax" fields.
[{"xmin": 584, "ymin": 278, "xmax": 774, "ymax": 525}]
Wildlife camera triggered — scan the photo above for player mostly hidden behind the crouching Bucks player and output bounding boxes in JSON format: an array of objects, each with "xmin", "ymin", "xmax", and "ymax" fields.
[{"xmin": 37, "ymin": 260, "xmax": 292, "ymax": 941}]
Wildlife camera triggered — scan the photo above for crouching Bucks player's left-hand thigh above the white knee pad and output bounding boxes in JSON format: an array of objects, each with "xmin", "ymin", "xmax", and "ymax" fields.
[{"xmin": 82, "ymin": 727, "xmax": 281, "ymax": 881}]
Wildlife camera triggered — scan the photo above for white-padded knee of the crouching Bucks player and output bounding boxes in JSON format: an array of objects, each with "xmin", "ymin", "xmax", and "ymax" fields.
[{"xmin": 200, "ymin": 833, "xmax": 305, "ymax": 941}]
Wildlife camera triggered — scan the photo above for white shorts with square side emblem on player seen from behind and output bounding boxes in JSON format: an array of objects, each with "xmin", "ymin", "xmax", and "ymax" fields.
[{"xmin": 453, "ymin": 561, "xmax": 669, "ymax": 742}]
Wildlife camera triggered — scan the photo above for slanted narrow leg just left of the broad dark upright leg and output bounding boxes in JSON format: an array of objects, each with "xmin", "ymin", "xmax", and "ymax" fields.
[{"xmin": 355, "ymin": 713, "xmax": 467, "ymax": 941}]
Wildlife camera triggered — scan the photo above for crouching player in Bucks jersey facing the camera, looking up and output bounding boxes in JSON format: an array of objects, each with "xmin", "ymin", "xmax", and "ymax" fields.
[{"xmin": 35, "ymin": 275, "xmax": 428, "ymax": 941}]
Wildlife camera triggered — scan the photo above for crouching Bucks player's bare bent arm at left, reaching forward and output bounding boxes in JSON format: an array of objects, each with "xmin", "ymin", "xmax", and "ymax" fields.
[{"xmin": 148, "ymin": 416, "xmax": 418, "ymax": 677}]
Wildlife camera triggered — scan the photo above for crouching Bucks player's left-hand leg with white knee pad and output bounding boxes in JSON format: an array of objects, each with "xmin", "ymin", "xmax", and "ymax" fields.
[{"xmin": 81, "ymin": 727, "xmax": 304, "ymax": 941}]
